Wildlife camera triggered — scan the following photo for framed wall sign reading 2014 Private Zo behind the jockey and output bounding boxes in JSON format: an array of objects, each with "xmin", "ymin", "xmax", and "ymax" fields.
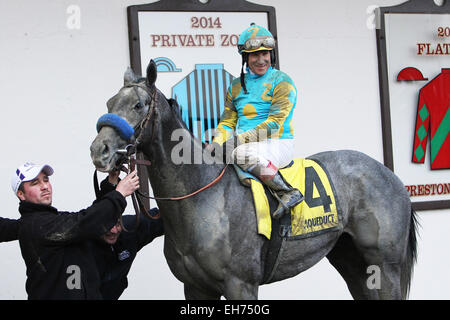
[{"xmin": 128, "ymin": 0, "xmax": 278, "ymax": 141}]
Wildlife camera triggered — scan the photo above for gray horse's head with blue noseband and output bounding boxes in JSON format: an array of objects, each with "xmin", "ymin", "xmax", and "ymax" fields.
[{"xmin": 91, "ymin": 60, "xmax": 157, "ymax": 172}]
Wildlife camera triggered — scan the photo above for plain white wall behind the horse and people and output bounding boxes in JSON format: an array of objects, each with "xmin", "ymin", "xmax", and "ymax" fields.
[{"xmin": 0, "ymin": 0, "xmax": 450, "ymax": 299}]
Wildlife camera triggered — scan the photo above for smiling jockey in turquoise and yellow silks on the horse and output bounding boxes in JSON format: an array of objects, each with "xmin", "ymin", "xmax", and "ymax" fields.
[{"xmin": 212, "ymin": 23, "xmax": 303, "ymax": 219}]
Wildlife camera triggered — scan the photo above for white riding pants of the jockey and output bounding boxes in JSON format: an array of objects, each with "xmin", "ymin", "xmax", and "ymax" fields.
[{"xmin": 231, "ymin": 139, "xmax": 294, "ymax": 171}]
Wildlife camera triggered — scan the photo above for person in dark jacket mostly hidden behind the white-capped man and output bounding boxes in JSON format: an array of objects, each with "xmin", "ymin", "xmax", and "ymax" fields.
[{"xmin": 92, "ymin": 172, "xmax": 164, "ymax": 300}]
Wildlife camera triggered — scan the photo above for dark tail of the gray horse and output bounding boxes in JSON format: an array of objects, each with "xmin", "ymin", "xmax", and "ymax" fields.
[{"xmin": 400, "ymin": 208, "xmax": 419, "ymax": 299}]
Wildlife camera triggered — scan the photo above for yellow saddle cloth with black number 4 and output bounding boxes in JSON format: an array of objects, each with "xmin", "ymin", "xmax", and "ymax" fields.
[{"xmin": 234, "ymin": 158, "xmax": 339, "ymax": 239}]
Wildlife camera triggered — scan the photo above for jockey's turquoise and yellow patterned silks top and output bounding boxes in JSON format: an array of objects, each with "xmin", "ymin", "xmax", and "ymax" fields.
[{"xmin": 213, "ymin": 67, "xmax": 297, "ymax": 145}]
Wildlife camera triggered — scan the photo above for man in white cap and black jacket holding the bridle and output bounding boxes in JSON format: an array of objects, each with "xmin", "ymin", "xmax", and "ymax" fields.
[{"xmin": 11, "ymin": 163, "xmax": 139, "ymax": 300}]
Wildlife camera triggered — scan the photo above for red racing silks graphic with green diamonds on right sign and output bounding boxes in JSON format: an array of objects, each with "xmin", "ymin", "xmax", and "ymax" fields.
[{"xmin": 412, "ymin": 68, "xmax": 450, "ymax": 169}]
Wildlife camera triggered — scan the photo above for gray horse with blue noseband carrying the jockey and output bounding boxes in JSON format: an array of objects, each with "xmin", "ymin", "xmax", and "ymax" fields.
[{"xmin": 91, "ymin": 61, "xmax": 416, "ymax": 299}]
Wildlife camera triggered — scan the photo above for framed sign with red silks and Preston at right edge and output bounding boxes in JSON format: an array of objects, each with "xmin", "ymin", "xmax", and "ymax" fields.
[{"xmin": 377, "ymin": 0, "xmax": 450, "ymax": 210}]
